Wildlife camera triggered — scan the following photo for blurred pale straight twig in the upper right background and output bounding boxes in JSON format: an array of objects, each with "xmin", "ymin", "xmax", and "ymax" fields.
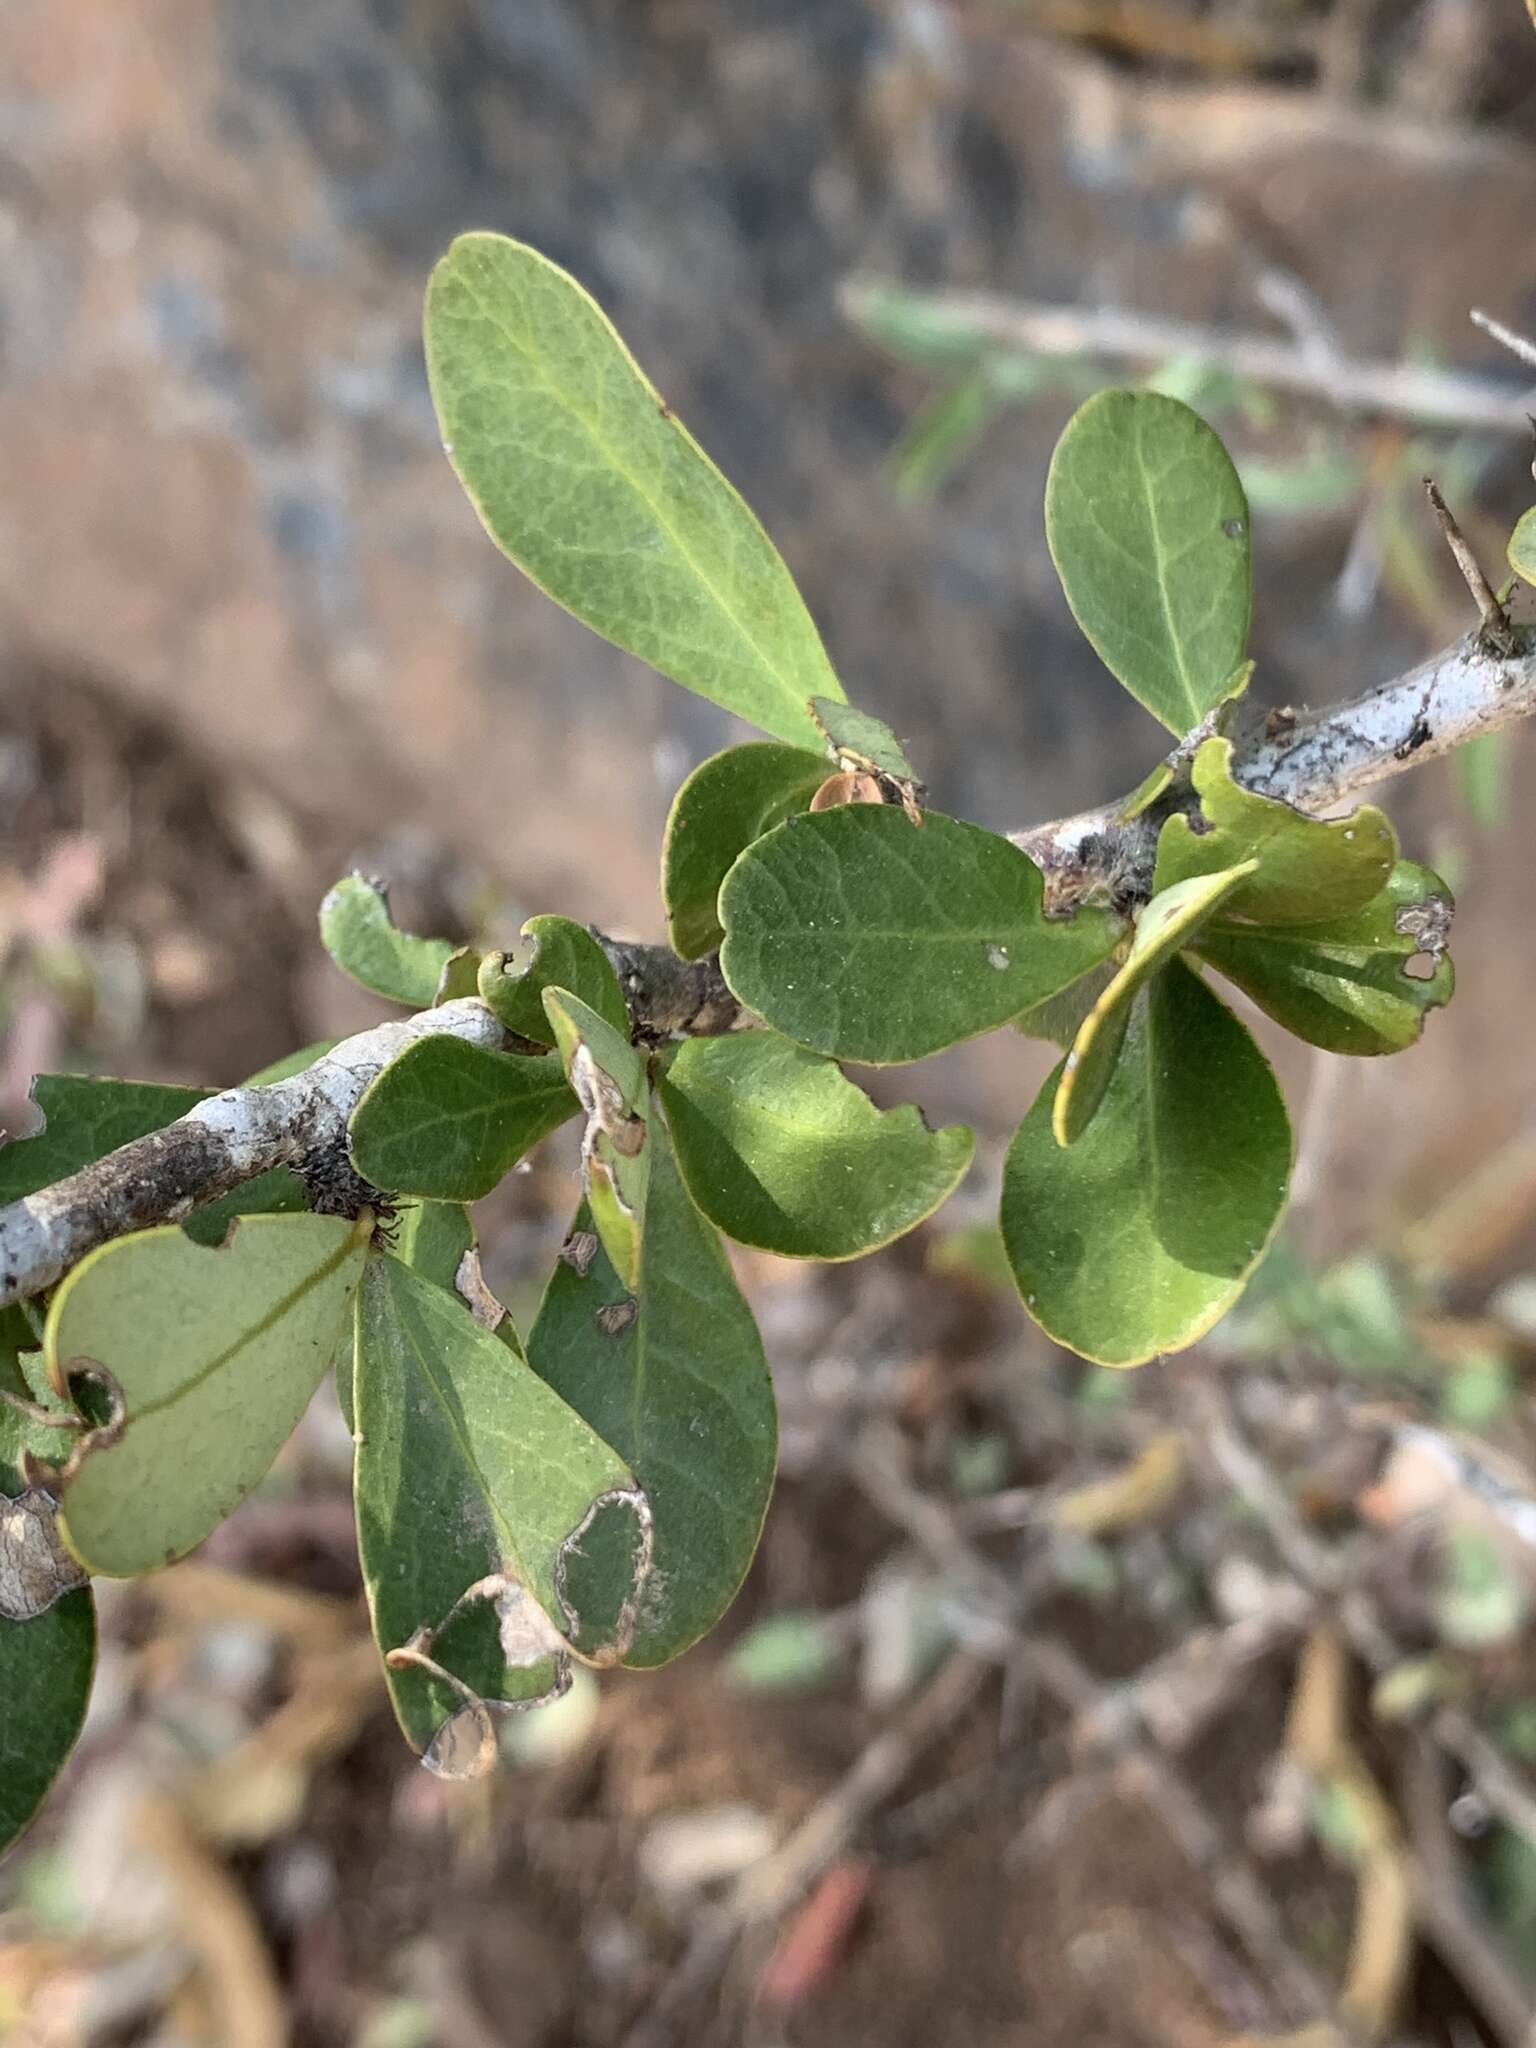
[{"xmin": 840, "ymin": 281, "xmax": 1522, "ymax": 434}]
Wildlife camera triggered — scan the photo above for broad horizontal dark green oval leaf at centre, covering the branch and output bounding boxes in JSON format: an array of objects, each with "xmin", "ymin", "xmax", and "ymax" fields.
[{"xmin": 721, "ymin": 805, "xmax": 1122, "ymax": 1067}]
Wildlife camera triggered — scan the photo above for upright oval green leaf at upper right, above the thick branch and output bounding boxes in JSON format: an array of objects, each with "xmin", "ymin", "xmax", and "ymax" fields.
[{"xmin": 1044, "ymin": 391, "xmax": 1253, "ymax": 733}]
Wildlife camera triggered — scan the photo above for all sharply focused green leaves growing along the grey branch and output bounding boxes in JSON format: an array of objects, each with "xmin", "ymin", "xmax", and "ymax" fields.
[{"xmin": 0, "ymin": 236, "xmax": 1452, "ymax": 1845}]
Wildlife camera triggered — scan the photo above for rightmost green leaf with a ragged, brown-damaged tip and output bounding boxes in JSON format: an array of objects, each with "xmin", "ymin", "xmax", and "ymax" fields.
[{"xmin": 1194, "ymin": 860, "xmax": 1456, "ymax": 1057}]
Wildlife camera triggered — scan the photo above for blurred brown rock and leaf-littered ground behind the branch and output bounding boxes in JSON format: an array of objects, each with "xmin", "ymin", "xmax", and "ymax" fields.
[{"xmin": 0, "ymin": 0, "xmax": 1536, "ymax": 2048}]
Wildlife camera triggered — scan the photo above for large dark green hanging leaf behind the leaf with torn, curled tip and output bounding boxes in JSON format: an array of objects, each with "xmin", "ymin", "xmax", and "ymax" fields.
[{"xmin": 528, "ymin": 1114, "xmax": 776, "ymax": 1667}]
